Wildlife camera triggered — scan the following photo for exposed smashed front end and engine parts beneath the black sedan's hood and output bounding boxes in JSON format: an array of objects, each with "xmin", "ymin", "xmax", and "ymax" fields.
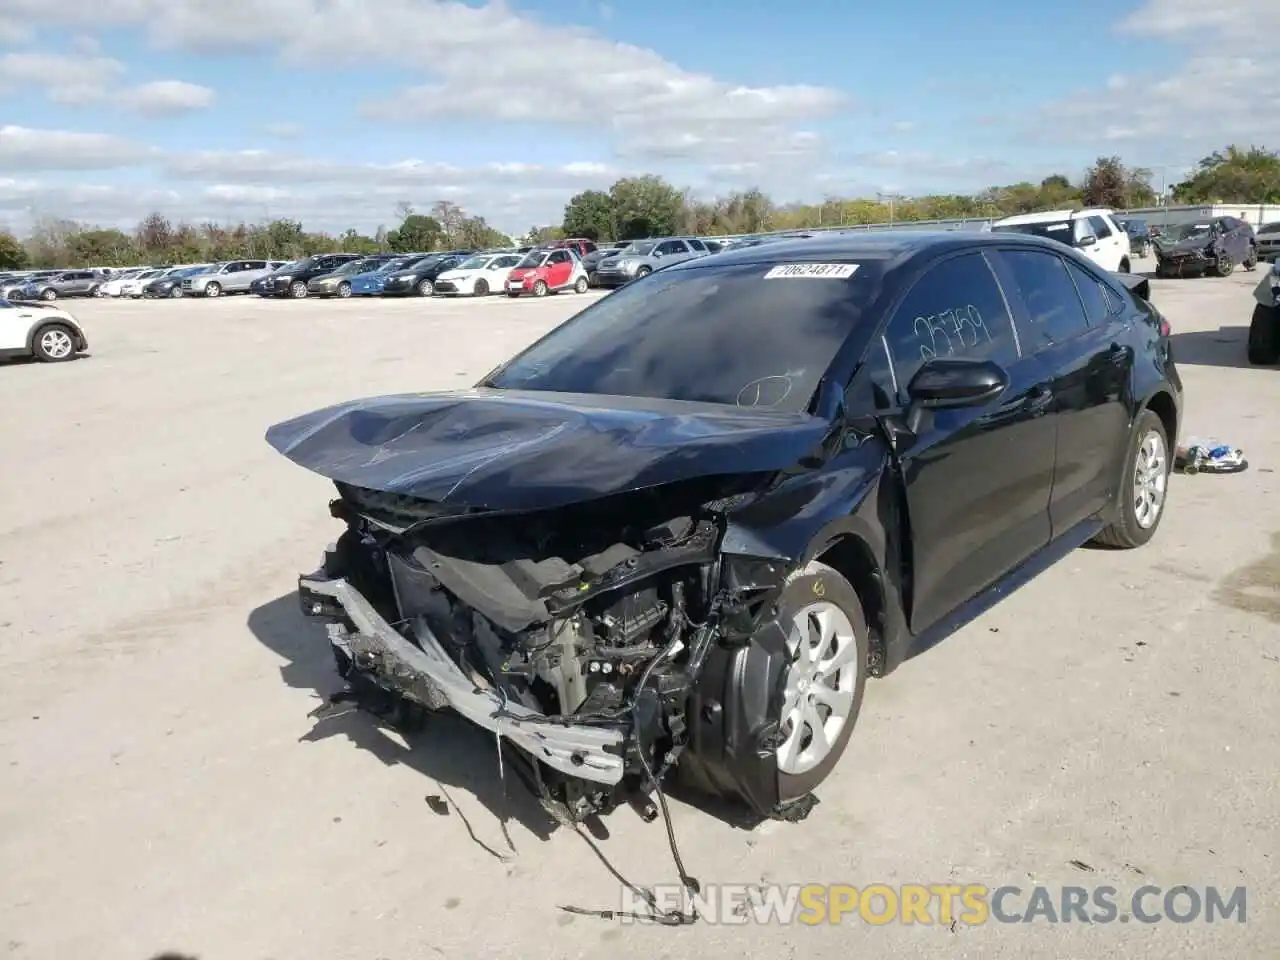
[{"xmin": 300, "ymin": 476, "xmax": 814, "ymax": 822}]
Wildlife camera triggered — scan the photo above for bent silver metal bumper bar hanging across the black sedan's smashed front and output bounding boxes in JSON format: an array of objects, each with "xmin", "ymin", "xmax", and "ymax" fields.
[{"xmin": 298, "ymin": 573, "xmax": 623, "ymax": 786}]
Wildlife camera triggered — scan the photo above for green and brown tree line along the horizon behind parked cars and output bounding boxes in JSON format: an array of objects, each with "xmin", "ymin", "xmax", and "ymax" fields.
[{"xmin": 0, "ymin": 146, "xmax": 1280, "ymax": 269}]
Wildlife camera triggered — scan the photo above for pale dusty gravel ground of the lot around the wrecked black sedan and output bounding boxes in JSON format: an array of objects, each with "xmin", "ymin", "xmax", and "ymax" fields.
[{"xmin": 0, "ymin": 273, "xmax": 1280, "ymax": 960}]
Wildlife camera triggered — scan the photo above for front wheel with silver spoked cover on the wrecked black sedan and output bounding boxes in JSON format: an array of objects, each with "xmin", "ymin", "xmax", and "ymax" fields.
[{"xmin": 777, "ymin": 562, "xmax": 869, "ymax": 803}]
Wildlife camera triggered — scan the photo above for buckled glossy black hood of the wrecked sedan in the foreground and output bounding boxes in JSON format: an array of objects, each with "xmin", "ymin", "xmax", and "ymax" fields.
[{"xmin": 266, "ymin": 389, "xmax": 831, "ymax": 509}]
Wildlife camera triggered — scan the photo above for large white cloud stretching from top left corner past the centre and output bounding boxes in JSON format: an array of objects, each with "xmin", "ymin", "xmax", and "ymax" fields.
[{"xmin": 6, "ymin": 0, "xmax": 847, "ymax": 159}]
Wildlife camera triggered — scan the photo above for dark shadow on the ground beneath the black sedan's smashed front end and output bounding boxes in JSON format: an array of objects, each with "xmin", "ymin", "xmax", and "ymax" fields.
[{"xmin": 248, "ymin": 594, "xmax": 760, "ymax": 855}]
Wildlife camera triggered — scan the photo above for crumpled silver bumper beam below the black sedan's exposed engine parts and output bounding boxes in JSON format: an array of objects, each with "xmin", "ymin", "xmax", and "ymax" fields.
[{"xmin": 298, "ymin": 576, "xmax": 623, "ymax": 786}]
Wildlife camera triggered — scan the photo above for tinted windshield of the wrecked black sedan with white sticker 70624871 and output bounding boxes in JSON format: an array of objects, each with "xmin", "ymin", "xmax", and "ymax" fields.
[{"xmin": 485, "ymin": 260, "xmax": 881, "ymax": 411}]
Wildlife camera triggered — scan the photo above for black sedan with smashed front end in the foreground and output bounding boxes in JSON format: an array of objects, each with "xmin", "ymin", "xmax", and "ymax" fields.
[{"xmin": 268, "ymin": 233, "xmax": 1181, "ymax": 820}]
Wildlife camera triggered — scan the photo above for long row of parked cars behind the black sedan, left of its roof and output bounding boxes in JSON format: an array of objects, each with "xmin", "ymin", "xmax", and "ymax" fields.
[{"xmin": 0, "ymin": 234, "xmax": 808, "ymax": 302}]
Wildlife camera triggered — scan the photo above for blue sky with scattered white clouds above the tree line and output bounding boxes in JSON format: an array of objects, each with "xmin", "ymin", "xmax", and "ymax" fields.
[{"xmin": 0, "ymin": 0, "xmax": 1280, "ymax": 232}]
